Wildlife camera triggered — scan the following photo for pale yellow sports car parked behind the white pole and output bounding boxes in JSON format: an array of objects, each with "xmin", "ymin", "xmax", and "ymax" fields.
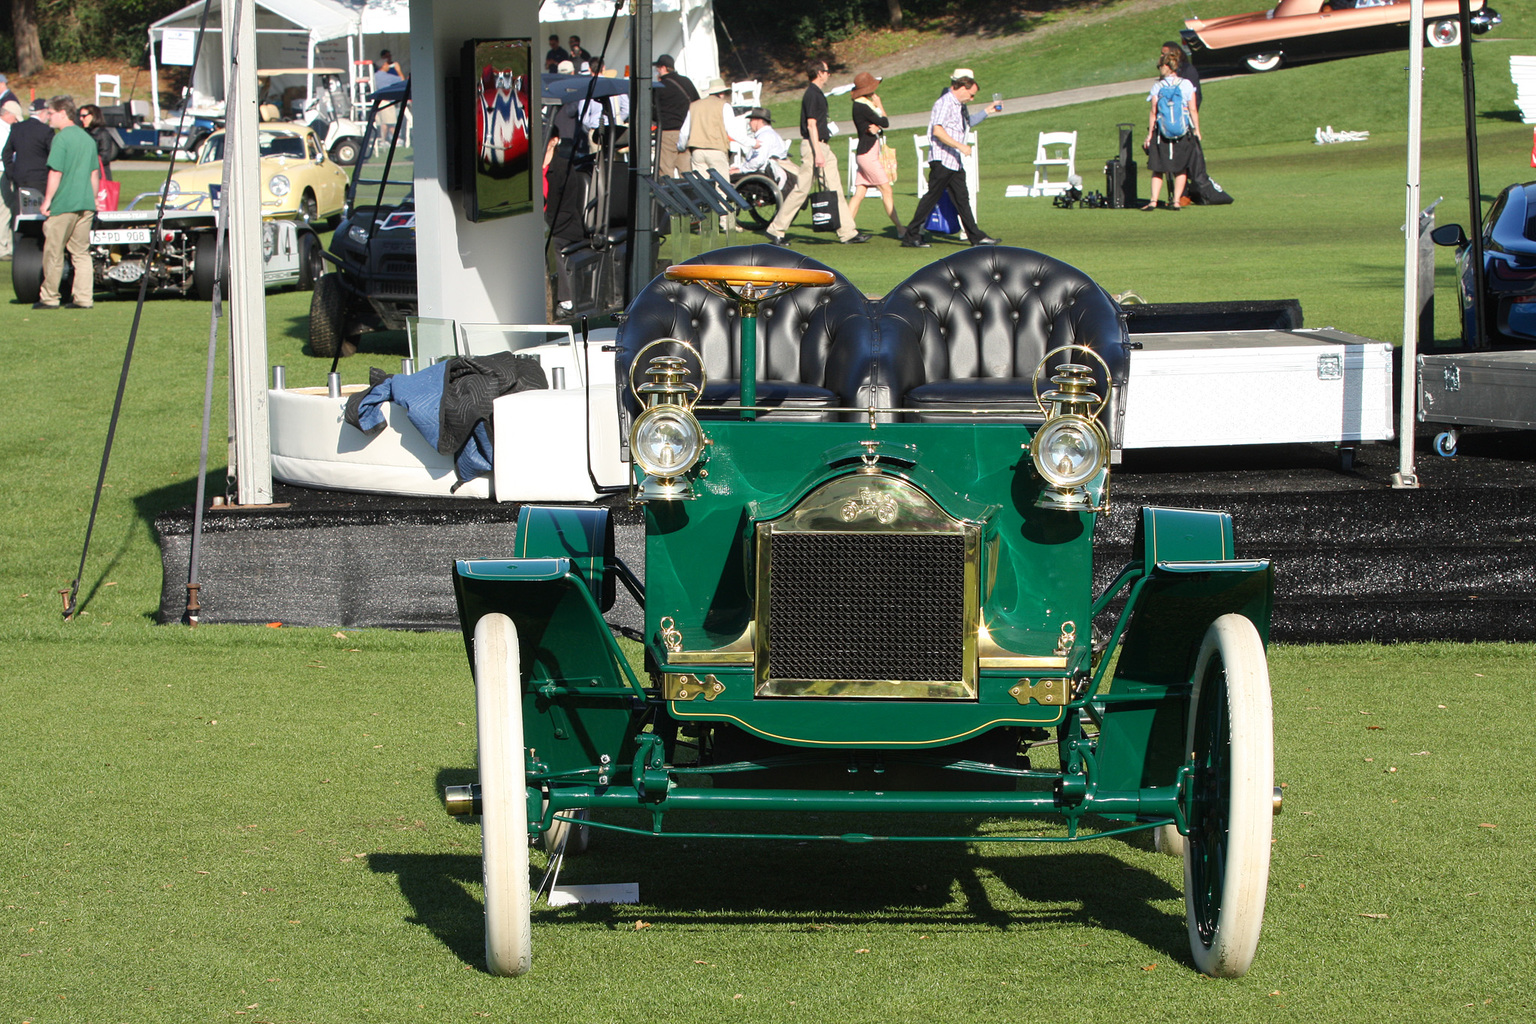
[{"xmin": 169, "ymin": 124, "xmax": 347, "ymax": 223}]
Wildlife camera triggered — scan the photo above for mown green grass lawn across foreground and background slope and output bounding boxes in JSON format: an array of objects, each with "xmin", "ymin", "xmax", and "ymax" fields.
[{"xmin": 0, "ymin": 16, "xmax": 1536, "ymax": 1024}]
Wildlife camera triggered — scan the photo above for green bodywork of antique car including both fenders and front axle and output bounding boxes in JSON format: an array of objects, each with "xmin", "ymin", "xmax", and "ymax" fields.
[{"xmin": 455, "ymin": 418, "xmax": 1273, "ymax": 838}]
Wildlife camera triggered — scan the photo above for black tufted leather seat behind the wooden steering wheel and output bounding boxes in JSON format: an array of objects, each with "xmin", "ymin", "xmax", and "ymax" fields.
[{"xmin": 617, "ymin": 246, "xmax": 872, "ymax": 421}]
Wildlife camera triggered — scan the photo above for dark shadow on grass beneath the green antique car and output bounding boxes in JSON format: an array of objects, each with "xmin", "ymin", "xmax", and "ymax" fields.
[{"xmin": 369, "ymin": 814, "xmax": 1189, "ymax": 969}]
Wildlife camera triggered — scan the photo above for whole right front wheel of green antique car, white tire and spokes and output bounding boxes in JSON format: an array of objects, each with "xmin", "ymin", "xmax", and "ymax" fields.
[{"xmin": 1184, "ymin": 614, "xmax": 1275, "ymax": 978}]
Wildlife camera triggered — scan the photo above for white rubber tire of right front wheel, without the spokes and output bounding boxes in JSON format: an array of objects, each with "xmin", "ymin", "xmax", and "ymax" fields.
[{"xmin": 1184, "ymin": 614, "xmax": 1275, "ymax": 978}]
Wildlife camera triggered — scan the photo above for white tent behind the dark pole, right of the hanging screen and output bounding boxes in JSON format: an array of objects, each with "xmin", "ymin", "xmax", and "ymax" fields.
[{"xmin": 533, "ymin": 0, "xmax": 720, "ymax": 92}]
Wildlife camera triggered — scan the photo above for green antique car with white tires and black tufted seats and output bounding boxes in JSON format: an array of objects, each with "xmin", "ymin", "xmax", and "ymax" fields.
[{"xmin": 447, "ymin": 246, "xmax": 1279, "ymax": 976}]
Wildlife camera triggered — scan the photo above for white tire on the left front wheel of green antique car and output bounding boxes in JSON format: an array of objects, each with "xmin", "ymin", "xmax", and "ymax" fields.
[{"xmin": 475, "ymin": 613, "xmax": 533, "ymax": 976}]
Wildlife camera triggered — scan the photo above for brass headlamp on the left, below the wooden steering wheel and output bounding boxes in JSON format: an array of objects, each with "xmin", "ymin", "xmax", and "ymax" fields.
[{"xmin": 630, "ymin": 339, "xmax": 705, "ymax": 502}]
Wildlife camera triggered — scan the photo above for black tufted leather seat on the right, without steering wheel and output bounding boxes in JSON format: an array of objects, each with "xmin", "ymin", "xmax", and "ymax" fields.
[{"xmin": 877, "ymin": 246, "xmax": 1130, "ymax": 434}]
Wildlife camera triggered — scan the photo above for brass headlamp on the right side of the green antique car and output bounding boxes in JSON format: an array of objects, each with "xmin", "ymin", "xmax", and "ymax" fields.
[{"xmin": 1029, "ymin": 345, "xmax": 1109, "ymax": 513}]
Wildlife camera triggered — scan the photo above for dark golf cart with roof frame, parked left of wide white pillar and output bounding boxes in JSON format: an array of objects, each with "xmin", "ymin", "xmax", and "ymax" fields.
[{"xmin": 309, "ymin": 81, "xmax": 416, "ymax": 358}]
